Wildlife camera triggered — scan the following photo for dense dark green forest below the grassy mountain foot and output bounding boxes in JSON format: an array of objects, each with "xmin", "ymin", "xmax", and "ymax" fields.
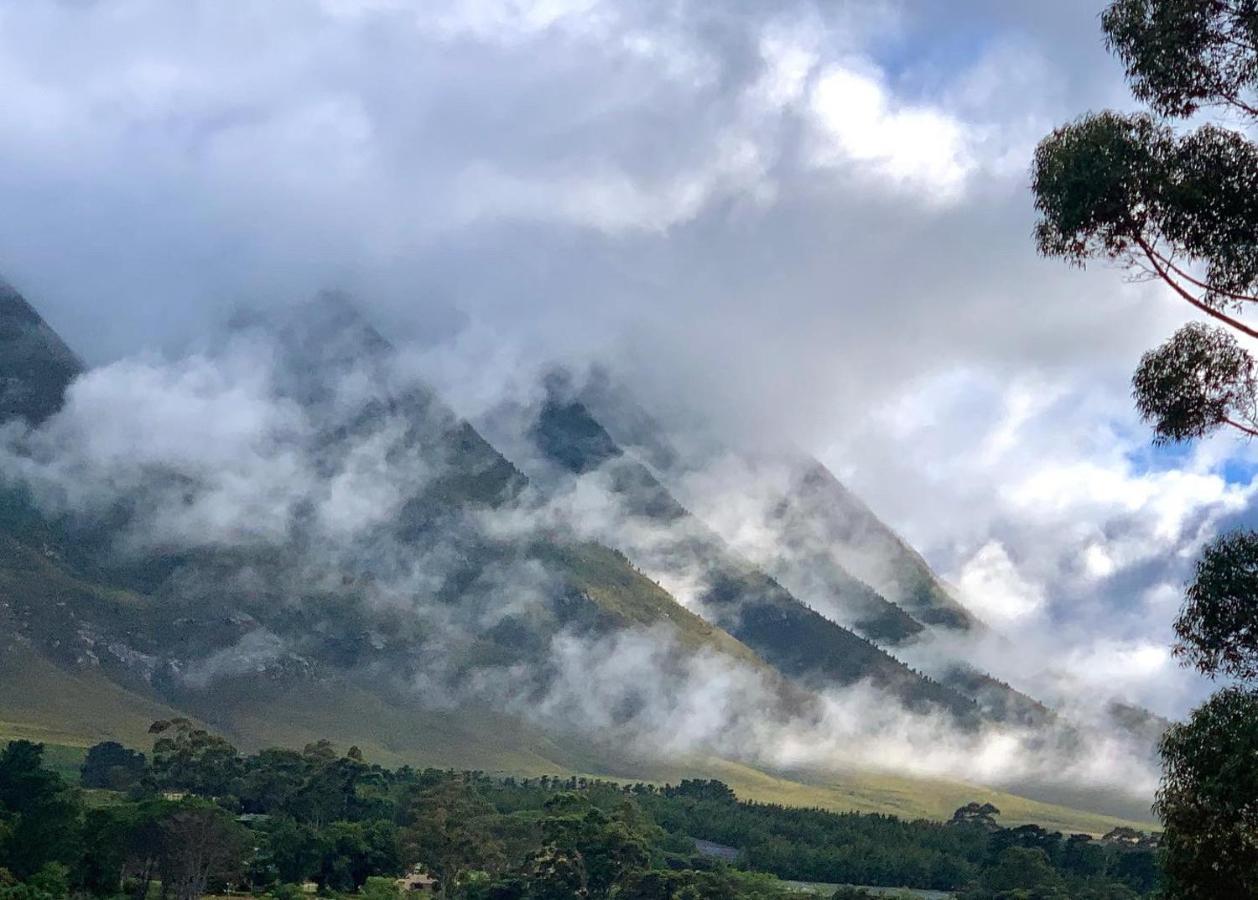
[{"xmin": 0, "ymin": 720, "xmax": 1157, "ymax": 900}]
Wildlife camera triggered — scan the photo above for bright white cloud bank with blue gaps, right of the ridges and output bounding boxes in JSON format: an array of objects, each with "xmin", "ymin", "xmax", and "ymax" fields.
[{"xmin": 832, "ymin": 373, "xmax": 1258, "ymax": 716}]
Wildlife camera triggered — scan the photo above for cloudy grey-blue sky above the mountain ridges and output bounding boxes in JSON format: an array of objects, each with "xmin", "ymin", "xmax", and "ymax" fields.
[{"xmin": 0, "ymin": 0, "xmax": 1237, "ymax": 714}]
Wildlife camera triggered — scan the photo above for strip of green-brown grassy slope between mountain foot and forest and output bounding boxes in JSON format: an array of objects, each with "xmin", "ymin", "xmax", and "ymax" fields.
[{"xmin": 0, "ymin": 644, "xmax": 1151, "ymax": 835}]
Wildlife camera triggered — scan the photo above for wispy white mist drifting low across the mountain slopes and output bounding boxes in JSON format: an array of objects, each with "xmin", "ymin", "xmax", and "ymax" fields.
[{"xmin": 0, "ymin": 331, "xmax": 1155, "ymax": 815}]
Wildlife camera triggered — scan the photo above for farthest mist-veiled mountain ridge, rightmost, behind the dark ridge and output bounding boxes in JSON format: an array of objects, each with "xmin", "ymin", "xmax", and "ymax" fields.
[{"xmin": 566, "ymin": 366, "xmax": 1166, "ymax": 757}]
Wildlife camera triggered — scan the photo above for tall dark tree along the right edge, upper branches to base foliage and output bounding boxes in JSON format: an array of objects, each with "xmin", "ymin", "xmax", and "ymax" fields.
[{"xmin": 1032, "ymin": 0, "xmax": 1258, "ymax": 900}]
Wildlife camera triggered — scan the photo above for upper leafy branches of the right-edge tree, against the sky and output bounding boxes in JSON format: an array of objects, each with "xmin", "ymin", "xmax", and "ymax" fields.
[{"xmin": 1032, "ymin": 0, "xmax": 1258, "ymax": 441}]
